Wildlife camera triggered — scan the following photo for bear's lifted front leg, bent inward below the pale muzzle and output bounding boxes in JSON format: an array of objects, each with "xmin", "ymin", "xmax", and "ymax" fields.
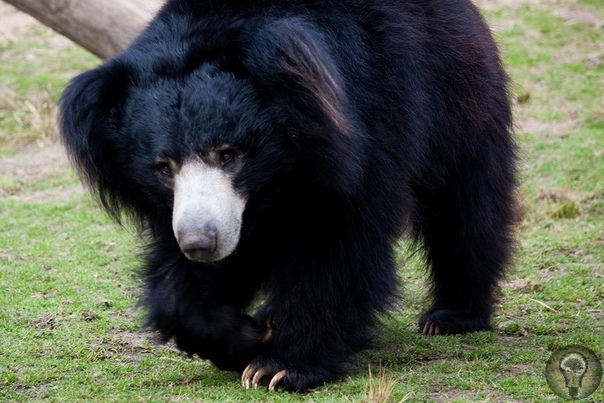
[{"xmin": 143, "ymin": 255, "xmax": 272, "ymax": 371}]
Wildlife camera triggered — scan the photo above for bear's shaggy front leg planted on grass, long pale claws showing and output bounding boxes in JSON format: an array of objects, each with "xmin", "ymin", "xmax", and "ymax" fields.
[{"xmin": 241, "ymin": 233, "xmax": 397, "ymax": 392}]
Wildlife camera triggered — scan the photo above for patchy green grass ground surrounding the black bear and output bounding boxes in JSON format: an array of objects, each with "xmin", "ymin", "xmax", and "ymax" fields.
[{"xmin": 0, "ymin": 0, "xmax": 604, "ymax": 402}]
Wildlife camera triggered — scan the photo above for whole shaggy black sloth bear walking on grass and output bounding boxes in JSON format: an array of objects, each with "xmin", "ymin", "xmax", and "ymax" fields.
[{"xmin": 60, "ymin": 0, "xmax": 516, "ymax": 391}]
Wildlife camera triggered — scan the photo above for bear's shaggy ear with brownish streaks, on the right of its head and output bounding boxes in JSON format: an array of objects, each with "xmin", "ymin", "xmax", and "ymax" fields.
[{"xmin": 241, "ymin": 18, "xmax": 367, "ymax": 193}]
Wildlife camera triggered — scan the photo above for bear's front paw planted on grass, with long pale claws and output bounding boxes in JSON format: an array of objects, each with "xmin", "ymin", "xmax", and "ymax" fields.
[{"xmin": 241, "ymin": 356, "xmax": 337, "ymax": 392}]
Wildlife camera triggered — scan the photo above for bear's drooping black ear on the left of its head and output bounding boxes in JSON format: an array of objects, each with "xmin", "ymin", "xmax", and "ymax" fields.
[{"xmin": 59, "ymin": 61, "xmax": 130, "ymax": 222}]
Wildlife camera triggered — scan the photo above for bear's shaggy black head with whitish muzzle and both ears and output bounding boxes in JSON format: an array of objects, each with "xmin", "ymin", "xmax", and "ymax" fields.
[{"xmin": 61, "ymin": 16, "xmax": 366, "ymax": 262}]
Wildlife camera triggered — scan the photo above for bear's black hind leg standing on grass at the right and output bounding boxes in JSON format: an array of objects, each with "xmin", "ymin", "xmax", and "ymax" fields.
[{"xmin": 417, "ymin": 167, "xmax": 515, "ymax": 335}]
